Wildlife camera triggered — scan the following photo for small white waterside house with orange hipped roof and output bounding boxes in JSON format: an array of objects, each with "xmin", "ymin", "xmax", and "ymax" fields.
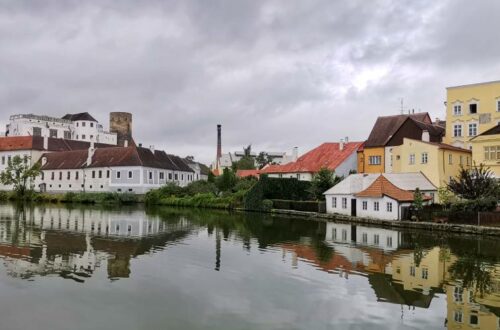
[{"xmin": 324, "ymin": 173, "xmax": 437, "ymax": 220}]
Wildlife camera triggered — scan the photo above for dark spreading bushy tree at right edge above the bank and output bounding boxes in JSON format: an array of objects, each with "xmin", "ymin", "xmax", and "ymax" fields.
[{"xmin": 448, "ymin": 164, "xmax": 500, "ymax": 200}]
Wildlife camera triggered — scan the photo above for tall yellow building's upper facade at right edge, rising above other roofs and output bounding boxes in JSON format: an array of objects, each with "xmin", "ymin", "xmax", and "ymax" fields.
[{"xmin": 445, "ymin": 81, "xmax": 500, "ymax": 149}]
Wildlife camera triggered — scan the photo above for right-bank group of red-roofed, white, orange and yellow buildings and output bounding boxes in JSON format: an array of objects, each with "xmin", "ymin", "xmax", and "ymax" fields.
[{"xmin": 245, "ymin": 81, "xmax": 500, "ymax": 220}]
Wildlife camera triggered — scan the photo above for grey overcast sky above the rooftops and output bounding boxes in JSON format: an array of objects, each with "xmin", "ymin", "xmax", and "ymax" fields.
[{"xmin": 0, "ymin": 0, "xmax": 500, "ymax": 163}]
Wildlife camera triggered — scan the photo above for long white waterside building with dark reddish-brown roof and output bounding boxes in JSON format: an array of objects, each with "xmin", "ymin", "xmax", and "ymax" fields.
[{"xmin": 35, "ymin": 146, "xmax": 196, "ymax": 194}]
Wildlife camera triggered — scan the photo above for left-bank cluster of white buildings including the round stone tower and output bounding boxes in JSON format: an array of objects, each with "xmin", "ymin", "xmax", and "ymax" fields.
[{"xmin": 0, "ymin": 112, "xmax": 209, "ymax": 194}]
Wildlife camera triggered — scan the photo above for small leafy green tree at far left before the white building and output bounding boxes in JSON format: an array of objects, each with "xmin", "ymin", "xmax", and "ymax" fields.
[{"xmin": 0, "ymin": 155, "xmax": 41, "ymax": 199}]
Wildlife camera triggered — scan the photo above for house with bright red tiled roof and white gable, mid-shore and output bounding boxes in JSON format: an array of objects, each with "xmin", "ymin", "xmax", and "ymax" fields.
[{"xmin": 260, "ymin": 141, "xmax": 363, "ymax": 181}]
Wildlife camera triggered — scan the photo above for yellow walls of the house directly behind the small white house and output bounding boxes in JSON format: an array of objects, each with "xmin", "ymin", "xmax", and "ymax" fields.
[{"xmin": 393, "ymin": 138, "xmax": 472, "ymax": 187}]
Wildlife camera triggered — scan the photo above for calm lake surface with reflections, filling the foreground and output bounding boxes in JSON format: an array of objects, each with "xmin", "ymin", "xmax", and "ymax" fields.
[{"xmin": 0, "ymin": 204, "xmax": 500, "ymax": 330}]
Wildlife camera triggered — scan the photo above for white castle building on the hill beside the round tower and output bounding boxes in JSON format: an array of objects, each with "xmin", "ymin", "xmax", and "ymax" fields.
[{"xmin": 5, "ymin": 112, "xmax": 117, "ymax": 145}]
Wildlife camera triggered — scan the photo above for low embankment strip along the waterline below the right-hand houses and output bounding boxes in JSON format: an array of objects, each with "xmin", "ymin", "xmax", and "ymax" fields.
[{"xmin": 235, "ymin": 208, "xmax": 500, "ymax": 236}]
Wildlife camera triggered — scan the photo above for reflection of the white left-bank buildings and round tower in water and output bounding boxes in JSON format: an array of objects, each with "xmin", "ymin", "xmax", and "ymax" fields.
[{"xmin": 0, "ymin": 207, "xmax": 191, "ymax": 282}]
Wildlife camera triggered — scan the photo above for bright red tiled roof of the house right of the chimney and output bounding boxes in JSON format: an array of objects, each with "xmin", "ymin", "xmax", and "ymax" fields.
[{"xmin": 260, "ymin": 142, "xmax": 363, "ymax": 174}]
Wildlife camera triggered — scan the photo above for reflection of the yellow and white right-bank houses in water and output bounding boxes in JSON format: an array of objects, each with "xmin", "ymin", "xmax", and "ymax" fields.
[{"xmin": 280, "ymin": 223, "xmax": 500, "ymax": 329}]
